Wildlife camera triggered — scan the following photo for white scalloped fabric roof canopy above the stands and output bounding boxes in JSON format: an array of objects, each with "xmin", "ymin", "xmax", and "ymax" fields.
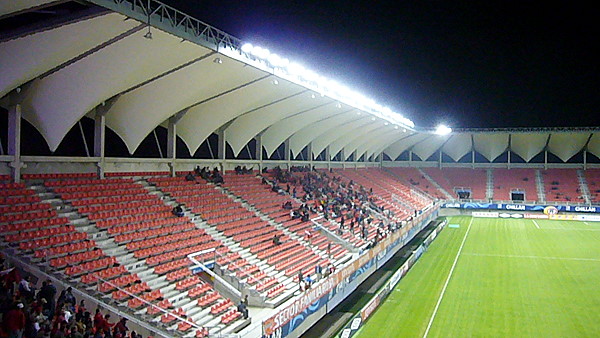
[{"xmin": 0, "ymin": 0, "xmax": 600, "ymax": 161}]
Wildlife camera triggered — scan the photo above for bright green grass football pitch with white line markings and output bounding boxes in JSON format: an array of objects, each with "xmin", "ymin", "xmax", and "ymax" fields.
[{"xmin": 358, "ymin": 217, "xmax": 600, "ymax": 337}]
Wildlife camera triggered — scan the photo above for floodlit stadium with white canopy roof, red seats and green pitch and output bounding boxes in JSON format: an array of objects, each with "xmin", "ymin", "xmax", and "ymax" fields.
[{"xmin": 0, "ymin": 0, "xmax": 600, "ymax": 337}]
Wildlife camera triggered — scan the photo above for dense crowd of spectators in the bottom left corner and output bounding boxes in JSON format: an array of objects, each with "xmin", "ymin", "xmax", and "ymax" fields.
[{"xmin": 0, "ymin": 257, "xmax": 141, "ymax": 338}]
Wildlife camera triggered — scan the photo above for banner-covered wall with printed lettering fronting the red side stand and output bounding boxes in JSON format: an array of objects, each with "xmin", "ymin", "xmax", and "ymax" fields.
[{"xmin": 262, "ymin": 206, "xmax": 439, "ymax": 338}]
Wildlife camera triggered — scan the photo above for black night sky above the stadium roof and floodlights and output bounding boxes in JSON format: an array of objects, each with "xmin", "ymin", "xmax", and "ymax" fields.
[{"xmin": 164, "ymin": 0, "xmax": 600, "ymax": 128}]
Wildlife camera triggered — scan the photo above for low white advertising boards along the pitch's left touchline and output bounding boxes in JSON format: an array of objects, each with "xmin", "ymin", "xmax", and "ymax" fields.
[{"xmin": 339, "ymin": 220, "xmax": 448, "ymax": 338}]
